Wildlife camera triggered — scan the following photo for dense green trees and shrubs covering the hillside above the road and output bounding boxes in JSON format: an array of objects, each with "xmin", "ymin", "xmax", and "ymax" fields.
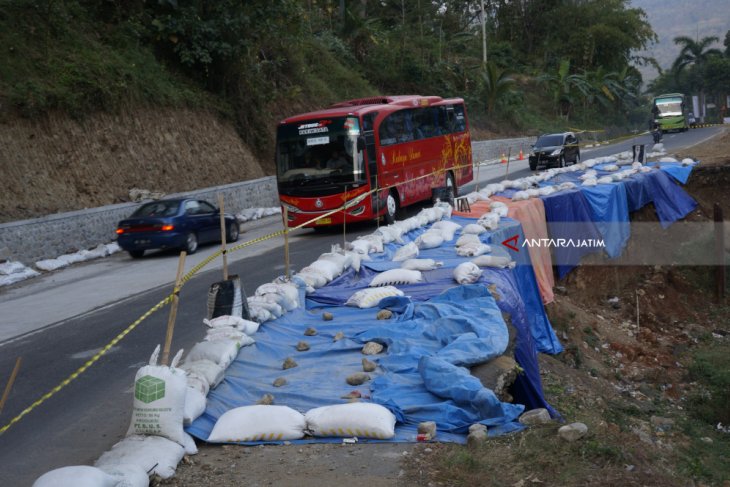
[{"xmin": 0, "ymin": 0, "xmax": 655, "ymax": 165}]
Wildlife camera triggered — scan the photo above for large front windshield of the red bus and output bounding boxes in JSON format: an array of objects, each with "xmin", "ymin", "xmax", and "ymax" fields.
[{"xmin": 276, "ymin": 117, "xmax": 365, "ymax": 187}]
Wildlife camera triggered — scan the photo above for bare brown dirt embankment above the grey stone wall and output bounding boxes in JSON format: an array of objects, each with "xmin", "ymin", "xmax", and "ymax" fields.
[{"xmin": 0, "ymin": 109, "xmax": 266, "ymax": 222}]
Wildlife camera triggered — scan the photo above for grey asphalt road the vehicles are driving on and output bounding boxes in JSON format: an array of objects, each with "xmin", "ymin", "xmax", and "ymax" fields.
[{"xmin": 0, "ymin": 127, "xmax": 719, "ymax": 486}]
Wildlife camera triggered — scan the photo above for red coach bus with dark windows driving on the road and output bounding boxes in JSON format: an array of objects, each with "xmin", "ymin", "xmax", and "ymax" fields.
[{"xmin": 276, "ymin": 95, "xmax": 473, "ymax": 227}]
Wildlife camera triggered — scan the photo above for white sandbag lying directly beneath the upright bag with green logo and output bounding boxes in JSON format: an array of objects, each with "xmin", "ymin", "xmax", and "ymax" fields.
[{"xmin": 94, "ymin": 435, "xmax": 185, "ymax": 479}]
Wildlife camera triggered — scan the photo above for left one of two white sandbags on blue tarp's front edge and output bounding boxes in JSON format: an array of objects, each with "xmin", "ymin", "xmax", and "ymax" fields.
[{"xmin": 207, "ymin": 405, "xmax": 307, "ymax": 443}]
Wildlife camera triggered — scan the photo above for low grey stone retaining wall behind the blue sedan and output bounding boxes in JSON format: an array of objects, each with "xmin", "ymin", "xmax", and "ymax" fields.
[{"xmin": 0, "ymin": 176, "xmax": 279, "ymax": 265}]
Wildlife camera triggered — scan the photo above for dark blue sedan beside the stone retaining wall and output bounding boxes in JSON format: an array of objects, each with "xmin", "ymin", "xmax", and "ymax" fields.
[{"xmin": 117, "ymin": 198, "xmax": 239, "ymax": 259}]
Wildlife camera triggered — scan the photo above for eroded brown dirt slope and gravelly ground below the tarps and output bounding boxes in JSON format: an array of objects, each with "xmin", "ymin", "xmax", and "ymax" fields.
[{"xmin": 154, "ymin": 132, "xmax": 730, "ymax": 487}]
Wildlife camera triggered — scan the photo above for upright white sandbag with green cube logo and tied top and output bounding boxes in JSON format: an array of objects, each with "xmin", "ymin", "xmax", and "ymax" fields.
[{"xmin": 127, "ymin": 342, "xmax": 186, "ymax": 444}]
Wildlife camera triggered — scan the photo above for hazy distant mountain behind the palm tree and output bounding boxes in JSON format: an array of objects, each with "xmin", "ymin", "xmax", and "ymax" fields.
[{"xmin": 631, "ymin": 0, "xmax": 730, "ymax": 82}]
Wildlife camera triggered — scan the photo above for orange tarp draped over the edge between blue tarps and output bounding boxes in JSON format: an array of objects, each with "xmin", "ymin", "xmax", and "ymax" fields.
[{"xmin": 453, "ymin": 196, "xmax": 555, "ymax": 304}]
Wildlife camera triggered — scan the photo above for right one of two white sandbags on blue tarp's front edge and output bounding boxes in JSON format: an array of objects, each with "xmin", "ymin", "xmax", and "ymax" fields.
[{"xmin": 304, "ymin": 402, "xmax": 396, "ymax": 440}]
